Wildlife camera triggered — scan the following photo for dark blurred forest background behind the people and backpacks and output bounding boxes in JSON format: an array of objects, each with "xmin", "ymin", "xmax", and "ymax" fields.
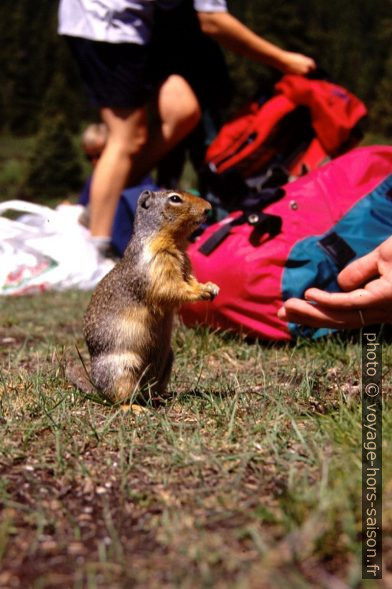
[{"xmin": 0, "ymin": 0, "xmax": 392, "ymax": 204}]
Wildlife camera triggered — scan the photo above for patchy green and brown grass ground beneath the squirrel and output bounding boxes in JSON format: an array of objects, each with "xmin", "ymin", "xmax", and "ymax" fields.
[{"xmin": 0, "ymin": 292, "xmax": 392, "ymax": 589}]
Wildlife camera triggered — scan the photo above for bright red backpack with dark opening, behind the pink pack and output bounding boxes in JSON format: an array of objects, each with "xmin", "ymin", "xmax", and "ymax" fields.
[{"xmin": 206, "ymin": 75, "xmax": 367, "ymax": 195}]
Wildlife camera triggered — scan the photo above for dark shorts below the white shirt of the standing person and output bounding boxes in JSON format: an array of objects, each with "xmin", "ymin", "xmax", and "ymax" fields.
[{"xmin": 65, "ymin": 36, "xmax": 153, "ymax": 109}]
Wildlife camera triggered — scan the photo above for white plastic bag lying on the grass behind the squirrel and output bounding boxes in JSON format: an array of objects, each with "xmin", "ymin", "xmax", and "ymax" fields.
[{"xmin": 0, "ymin": 200, "xmax": 113, "ymax": 295}]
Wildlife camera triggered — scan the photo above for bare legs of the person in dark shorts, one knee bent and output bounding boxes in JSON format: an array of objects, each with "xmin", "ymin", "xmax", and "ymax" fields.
[{"xmin": 90, "ymin": 75, "xmax": 201, "ymax": 238}]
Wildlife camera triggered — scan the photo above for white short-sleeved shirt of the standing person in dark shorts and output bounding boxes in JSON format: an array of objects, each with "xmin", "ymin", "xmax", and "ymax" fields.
[{"xmin": 58, "ymin": 0, "xmax": 227, "ymax": 45}]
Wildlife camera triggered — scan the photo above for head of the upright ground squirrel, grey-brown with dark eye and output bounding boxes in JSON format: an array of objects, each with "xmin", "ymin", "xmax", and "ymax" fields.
[{"xmin": 134, "ymin": 190, "xmax": 211, "ymax": 240}]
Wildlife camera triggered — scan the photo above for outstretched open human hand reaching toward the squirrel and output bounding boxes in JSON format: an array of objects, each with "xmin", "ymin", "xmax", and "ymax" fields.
[{"xmin": 278, "ymin": 237, "xmax": 392, "ymax": 329}]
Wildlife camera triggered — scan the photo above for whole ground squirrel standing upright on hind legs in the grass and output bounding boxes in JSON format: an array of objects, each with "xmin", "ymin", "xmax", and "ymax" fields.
[{"xmin": 68, "ymin": 190, "xmax": 219, "ymax": 402}]
